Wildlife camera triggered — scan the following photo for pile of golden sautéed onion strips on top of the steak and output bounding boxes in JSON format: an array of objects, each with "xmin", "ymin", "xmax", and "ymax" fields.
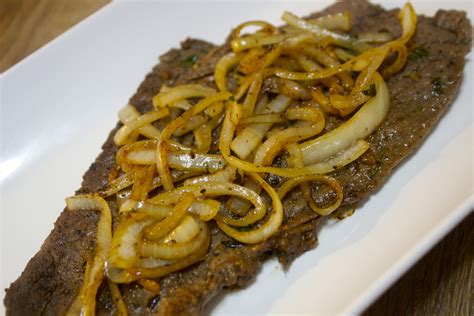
[{"xmin": 66, "ymin": 4, "xmax": 416, "ymax": 315}]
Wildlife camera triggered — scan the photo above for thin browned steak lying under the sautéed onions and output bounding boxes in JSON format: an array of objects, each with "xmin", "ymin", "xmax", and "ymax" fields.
[{"xmin": 4, "ymin": 1, "xmax": 471, "ymax": 315}]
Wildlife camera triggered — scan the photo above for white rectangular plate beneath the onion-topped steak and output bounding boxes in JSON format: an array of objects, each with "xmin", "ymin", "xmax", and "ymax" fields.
[{"xmin": 0, "ymin": 1, "xmax": 474, "ymax": 315}]
